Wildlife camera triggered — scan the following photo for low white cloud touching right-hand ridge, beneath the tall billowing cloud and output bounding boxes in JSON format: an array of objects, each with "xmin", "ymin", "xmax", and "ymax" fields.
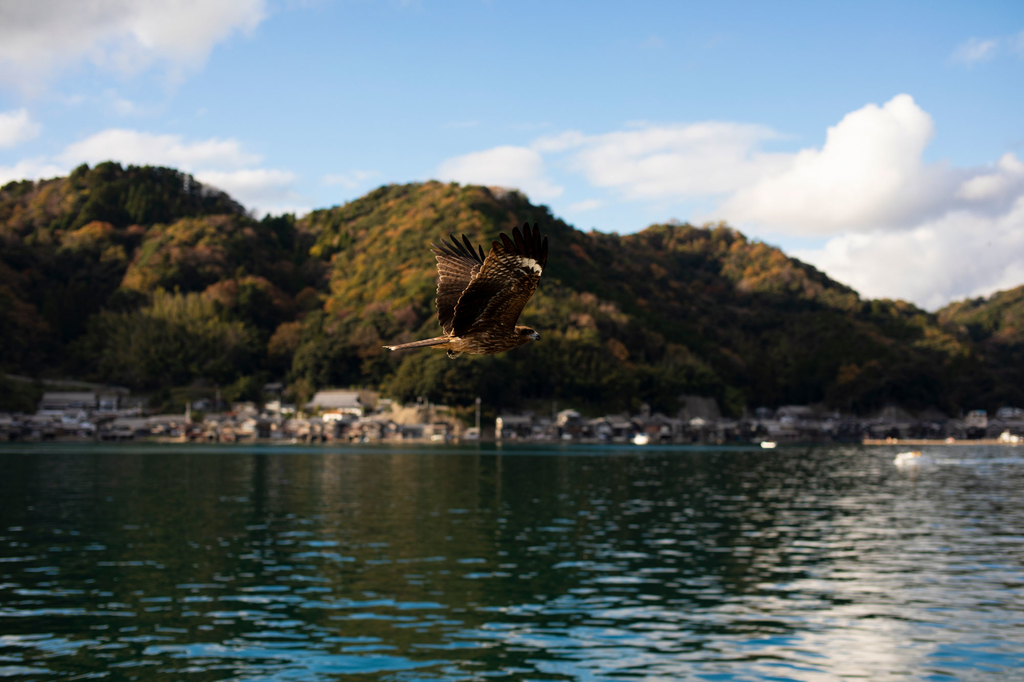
[{"xmin": 794, "ymin": 197, "xmax": 1024, "ymax": 309}]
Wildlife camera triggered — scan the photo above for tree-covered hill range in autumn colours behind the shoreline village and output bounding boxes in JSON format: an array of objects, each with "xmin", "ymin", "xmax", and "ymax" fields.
[{"xmin": 0, "ymin": 163, "xmax": 1024, "ymax": 414}]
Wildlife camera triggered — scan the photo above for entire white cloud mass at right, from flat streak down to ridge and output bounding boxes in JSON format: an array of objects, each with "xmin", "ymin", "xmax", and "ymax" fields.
[{"xmin": 520, "ymin": 94, "xmax": 1024, "ymax": 307}]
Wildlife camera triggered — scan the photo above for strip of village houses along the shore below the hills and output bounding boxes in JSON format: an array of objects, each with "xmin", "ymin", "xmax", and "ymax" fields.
[{"xmin": 0, "ymin": 384, "xmax": 1024, "ymax": 444}]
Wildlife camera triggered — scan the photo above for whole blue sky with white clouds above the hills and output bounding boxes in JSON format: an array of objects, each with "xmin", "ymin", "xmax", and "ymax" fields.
[{"xmin": 0, "ymin": 0, "xmax": 1024, "ymax": 308}]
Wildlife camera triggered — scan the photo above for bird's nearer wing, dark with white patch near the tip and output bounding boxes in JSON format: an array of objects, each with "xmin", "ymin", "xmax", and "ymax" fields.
[{"xmin": 452, "ymin": 223, "xmax": 548, "ymax": 336}]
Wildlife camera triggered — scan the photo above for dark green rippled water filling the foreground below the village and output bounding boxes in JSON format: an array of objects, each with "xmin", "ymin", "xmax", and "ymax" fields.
[{"xmin": 0, "ymin": 445, "xmax": 1024, "ymax": 681}]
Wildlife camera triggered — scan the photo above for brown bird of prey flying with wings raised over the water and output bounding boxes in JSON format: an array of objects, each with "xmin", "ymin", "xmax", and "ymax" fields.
[{"xmin": 384, "ymin": 222, "xmax": 548, "ymax": 357}]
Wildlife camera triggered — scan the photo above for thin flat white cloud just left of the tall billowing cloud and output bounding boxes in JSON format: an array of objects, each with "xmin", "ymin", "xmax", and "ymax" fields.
[{"xmin": 532, "ymin": 121, "xmax": 785, "ymax": 200}]
